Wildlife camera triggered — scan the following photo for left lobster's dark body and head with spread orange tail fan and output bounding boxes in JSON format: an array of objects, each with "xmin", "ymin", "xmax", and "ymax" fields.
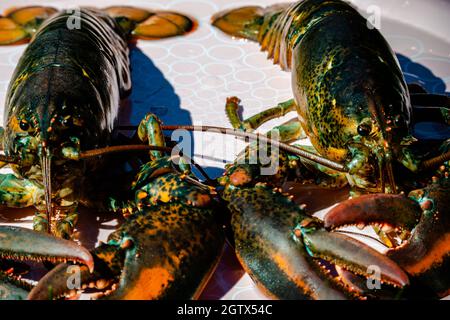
[{"xmin": 0, "ymin": 6, "xmax": 194, "ymax": 298}]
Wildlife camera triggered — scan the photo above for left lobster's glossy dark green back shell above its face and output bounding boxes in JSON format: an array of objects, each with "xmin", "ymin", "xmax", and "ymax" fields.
[{"xmin": 4, "ymin": 9, "xmax": 131, "ymax": 154}]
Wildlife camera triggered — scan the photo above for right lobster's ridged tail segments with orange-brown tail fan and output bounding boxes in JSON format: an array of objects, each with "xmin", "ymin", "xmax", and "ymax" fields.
[{"xmin": 212, "ymin": 0, "xmax": 362, "ymax": 70}]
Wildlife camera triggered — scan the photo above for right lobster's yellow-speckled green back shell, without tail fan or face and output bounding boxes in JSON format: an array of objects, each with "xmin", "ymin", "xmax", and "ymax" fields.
[{"xmin": 258, "ymin": 0, "xmax": 411, "ymax": 161}]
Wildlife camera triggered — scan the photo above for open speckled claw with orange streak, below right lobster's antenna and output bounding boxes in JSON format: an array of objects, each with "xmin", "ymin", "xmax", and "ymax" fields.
[{"xmin": 229, "ymin": 184, "xmax": 409, "ymax": 299}]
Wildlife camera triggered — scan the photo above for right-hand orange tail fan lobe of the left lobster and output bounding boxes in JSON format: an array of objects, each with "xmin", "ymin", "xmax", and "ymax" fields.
[{"xmin": 103, "ymin": 6, "xmax": 194, "ymax": 40}]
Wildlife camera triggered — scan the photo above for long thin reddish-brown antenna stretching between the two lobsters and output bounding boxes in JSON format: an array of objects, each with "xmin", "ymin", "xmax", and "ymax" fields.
[{"xmin": 161, "ymin": 125, "xmax": 348, "ymax": 172}]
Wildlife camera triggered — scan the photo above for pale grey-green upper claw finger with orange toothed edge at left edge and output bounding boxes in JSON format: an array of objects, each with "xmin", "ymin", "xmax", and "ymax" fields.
[{"xmin": 0, "ymin": 226, "xmax": 94, "ymax": 272}]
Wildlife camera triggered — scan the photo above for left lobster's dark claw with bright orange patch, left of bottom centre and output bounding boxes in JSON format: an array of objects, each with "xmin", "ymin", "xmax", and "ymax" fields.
[{"xmin": 5, "ymin": 114, "xmax": 225, "ymax": 300}]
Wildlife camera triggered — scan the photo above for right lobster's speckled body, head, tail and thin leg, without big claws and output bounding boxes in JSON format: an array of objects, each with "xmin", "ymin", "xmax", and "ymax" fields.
[{"xmin": 212, "ymin": 0, "xmax": 450, "ymax": 193}]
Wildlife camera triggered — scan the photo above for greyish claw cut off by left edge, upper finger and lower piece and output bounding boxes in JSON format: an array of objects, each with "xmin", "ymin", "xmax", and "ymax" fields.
[{"xmin": 0, "ymin": 226, "xmax": 94, "ymax": 300}]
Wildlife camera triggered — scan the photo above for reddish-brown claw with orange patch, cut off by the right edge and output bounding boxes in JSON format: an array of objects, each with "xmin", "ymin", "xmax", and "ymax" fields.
[{"xmin": 324, "ymin": 177, "xmax": 450, "ymax": 297}]
